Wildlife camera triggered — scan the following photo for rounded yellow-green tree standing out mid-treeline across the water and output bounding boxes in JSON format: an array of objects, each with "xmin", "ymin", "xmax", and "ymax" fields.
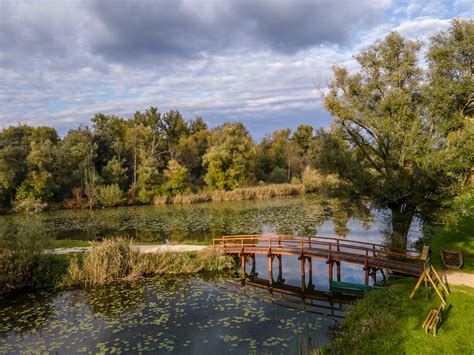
[{"xmin": 203, "ymin": 123, "xmax": 255, "ymax": 190}]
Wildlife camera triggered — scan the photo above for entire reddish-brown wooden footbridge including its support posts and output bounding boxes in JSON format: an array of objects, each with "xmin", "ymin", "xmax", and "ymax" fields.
[{"xmin": 212, "ymin": 234, "xmax": 423, "ymax": 287}]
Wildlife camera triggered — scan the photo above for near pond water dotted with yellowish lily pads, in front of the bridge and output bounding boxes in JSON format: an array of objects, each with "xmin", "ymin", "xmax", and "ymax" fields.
[{"xmin": 0, "ymin": 276, "xmax": 335, "ymax": 354}]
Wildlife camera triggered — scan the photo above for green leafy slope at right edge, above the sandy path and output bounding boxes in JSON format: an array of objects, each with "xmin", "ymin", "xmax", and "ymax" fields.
[{"xmin": 426, "ymin": 201, "xmax": 474, "ymax": 273}]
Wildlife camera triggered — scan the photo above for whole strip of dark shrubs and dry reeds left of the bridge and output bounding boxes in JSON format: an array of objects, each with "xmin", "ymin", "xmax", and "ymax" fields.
[{"xmin": 0, "ymin": 237, "xmax": 235, "ymax": 296}]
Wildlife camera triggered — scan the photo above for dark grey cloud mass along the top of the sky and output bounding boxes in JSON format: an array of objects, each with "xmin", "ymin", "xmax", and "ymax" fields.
[{"xmin": 89, "ymin": 0, "xmax": 381, "ymax": 64}]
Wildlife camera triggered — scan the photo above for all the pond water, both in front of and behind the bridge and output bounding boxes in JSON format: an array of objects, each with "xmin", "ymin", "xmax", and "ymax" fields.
[{"xmin": 0, "ymin": 196, "xmax": 417, "ymax": 354}]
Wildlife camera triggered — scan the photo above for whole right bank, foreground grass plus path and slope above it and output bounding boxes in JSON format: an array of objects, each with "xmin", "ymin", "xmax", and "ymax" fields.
[{"xmin": 326, "ymin": 199, "xmax": 474, "ymax": 354}]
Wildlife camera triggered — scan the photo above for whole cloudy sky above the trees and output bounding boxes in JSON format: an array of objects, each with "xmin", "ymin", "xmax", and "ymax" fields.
[{"xmin": 0, "ymin": 0, "xmax": 474, "ymax": 140}]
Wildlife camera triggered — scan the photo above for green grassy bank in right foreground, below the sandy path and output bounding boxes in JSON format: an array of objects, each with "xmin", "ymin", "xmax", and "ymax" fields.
[{"xmin": 328, "ymin": 279, "xmax": 474, "ymax": 354}]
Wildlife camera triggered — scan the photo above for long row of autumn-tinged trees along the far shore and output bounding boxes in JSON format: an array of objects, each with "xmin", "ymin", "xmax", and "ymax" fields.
[{"xmin": 0, "ymin": 107, "xmax": 324, "ymax": 212}]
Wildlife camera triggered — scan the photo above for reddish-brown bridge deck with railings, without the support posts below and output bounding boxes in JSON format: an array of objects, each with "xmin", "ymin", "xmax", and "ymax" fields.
[{"xmin": 213, "ymin": 235, "xmax": 422, "ymax": 276}]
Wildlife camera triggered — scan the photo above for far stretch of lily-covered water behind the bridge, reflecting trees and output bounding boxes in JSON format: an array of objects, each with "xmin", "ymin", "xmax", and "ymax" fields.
[{"xmin": 0, "ymin": 195, "xmax": 376, "ymax": 243}]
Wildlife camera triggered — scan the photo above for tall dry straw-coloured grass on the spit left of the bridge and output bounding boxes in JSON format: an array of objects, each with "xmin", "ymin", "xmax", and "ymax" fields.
[{"xmin": 64, "ymin": 238, "xmax": 234, "ymax": 287}]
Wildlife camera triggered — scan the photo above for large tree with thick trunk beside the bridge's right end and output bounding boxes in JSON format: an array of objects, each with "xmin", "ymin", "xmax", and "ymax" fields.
[{"xmin": 323, "ymin": 21, "xmax": 474, "ymax": 248}]
